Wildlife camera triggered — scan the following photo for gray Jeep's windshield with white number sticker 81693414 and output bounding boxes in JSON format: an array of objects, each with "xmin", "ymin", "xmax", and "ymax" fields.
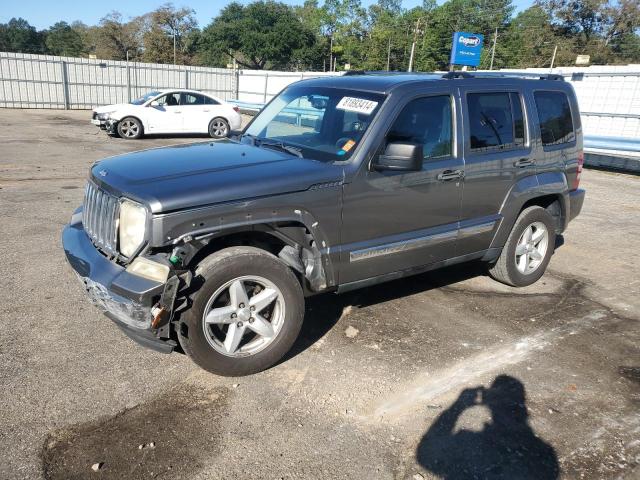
[{"xmin": 243, "ymin": 87, "xmax": 384, "ymax": 162}]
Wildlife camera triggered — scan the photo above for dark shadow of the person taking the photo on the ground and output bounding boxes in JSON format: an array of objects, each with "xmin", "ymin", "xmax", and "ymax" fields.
[{"xmin": 416, "ymin": 375, "xmax": 559, "ymax": 480}]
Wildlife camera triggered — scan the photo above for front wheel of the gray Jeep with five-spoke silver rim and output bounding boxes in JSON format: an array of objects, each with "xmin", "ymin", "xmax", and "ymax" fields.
[{"xmin": 178, "ymin": 247, "xmax": 304, "ymax": 376}]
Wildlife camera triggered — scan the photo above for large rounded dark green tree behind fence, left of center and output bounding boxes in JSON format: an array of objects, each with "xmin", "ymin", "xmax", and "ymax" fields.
[{"xmin": 202, "ymin": 1, "xmax": 314, "ymax": 70}]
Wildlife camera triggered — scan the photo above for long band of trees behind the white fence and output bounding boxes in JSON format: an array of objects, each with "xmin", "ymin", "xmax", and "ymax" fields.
[{"xmin": 0, "ymin": 0, "xmax": 640, "ymax": 71}]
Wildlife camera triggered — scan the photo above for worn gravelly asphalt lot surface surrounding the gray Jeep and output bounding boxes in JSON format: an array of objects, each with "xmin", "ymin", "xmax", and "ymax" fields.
[{"xmin": 0, "ymin": 109, "xmax": 640, "ymax": 479}]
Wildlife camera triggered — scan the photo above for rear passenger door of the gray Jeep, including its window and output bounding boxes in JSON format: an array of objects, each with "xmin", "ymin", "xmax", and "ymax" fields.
[{"xmin": 457, "ymin": 85, "xmax": 537, "ymax": 255}]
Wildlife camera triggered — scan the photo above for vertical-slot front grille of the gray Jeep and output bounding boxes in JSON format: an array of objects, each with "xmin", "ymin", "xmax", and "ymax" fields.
[{"xmin": 82, "ymin": 182, "xmax": 119, "ymax": 256}]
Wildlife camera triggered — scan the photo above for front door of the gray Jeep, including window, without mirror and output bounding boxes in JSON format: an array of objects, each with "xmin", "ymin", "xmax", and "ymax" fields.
[{"xmin": 340, "ymin": 93, "xmax": 464, "ymax": 283}]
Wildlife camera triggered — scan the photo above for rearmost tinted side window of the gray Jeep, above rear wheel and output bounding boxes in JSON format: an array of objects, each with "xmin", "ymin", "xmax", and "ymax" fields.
[{"xmin": 534, "ymin": 92, "xmax": 576, "ymax": 145}]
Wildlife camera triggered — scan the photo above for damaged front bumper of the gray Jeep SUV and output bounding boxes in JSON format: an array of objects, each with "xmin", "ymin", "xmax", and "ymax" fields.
[{"xmin": 62, "ymin": 211, "xmax": 176, "ymax": 353}]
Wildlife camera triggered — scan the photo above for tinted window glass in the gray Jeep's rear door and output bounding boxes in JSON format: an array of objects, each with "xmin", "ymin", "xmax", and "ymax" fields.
[{"xmin": 467, "ymin": 92, "xmax": 525, "ymax": 151}]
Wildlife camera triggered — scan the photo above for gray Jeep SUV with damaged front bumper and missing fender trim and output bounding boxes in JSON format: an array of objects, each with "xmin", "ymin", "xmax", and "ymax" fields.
[{"xmin": 62, "ymin": 73, "xmax": 584, "ymax": 375}]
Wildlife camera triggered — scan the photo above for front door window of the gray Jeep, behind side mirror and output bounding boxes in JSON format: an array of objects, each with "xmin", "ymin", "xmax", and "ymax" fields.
[{"xmin": 387, "ymin": 95, "xmax": 452, "ymax": 159}]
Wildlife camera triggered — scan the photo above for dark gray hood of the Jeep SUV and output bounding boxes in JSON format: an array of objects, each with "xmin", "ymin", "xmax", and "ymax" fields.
[{"xmin": 91, "ymin": 140, "xmax": 343, "ymax": 213}]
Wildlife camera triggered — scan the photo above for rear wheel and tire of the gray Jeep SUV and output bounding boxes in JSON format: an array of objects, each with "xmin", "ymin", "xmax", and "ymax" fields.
[{"xmin": 489, "ymin": 206, "xmax": 556, "ymax": 287}]
